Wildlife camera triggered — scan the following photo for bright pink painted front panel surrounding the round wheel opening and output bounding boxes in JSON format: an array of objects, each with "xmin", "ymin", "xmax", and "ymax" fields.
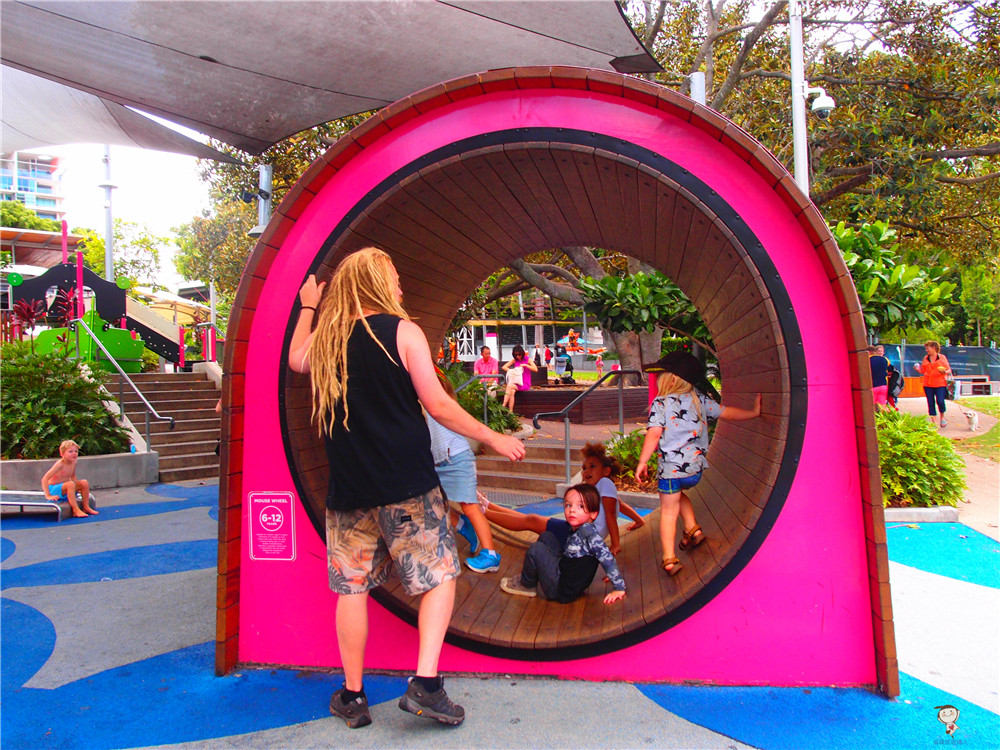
[{"xmin": 240, "ymin": 90, "xmax": 875, "ymax": 685}]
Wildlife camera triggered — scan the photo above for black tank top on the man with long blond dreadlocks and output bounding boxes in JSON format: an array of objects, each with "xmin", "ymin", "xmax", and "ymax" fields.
[{"xmin": 325, "ymin": 314, "xmax": 438, "ymax": 510}]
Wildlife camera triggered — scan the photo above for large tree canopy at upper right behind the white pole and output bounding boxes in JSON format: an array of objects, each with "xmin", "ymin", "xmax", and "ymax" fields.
[{"xmin": 625, "ymin": 0, "xmax": 1000, "ymax": 266}]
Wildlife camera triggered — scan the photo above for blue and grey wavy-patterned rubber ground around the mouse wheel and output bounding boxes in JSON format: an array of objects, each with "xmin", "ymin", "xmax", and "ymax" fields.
[{"xmin": 0, "ymin": 485, "xmax": 1000, "ymax": 750}]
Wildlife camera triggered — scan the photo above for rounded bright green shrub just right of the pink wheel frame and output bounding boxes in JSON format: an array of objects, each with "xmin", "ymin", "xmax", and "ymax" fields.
[{"xmin": 875, "ymin": 411, "xmax": 965, "ymax": 507}]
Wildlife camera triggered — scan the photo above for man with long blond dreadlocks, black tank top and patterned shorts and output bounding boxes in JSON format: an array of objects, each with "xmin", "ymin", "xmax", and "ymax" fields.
[{"xmin": 289, "ymin": 247, "xmax": 524, "ymax": 728}]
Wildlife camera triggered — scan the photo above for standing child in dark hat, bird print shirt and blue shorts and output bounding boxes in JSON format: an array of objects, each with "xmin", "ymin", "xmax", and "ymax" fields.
[{"xmin": 635, "ymin": 351, "xmax": 760, "ymax": 576}]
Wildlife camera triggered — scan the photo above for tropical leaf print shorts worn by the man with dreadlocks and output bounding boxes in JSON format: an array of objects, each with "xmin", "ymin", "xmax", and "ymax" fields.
[{"xmin": 326, "ymin": 487, "xmax": 461, "ymax": 596}]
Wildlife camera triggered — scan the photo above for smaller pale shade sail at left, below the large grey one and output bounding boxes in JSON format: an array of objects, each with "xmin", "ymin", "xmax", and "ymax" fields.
[{"xmin": 3, "ymin": 65, "xmax": 245, "ymax": 163}]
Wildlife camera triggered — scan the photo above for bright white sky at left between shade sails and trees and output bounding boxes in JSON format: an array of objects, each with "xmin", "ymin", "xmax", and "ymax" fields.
[{"xmin": 46, "ymin": 142, "xmax": 209, "ymax": 291}]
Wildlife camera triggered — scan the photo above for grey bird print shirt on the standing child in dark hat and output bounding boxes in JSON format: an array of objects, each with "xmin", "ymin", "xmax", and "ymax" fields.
[{"xmin": 646, "ymin": 393, "xmax": 722, "ymax": 479}]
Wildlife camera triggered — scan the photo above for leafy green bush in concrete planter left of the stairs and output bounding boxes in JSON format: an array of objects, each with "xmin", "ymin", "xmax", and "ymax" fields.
[{"xmin": 0, "ymin": 342, "xmax": 129, "ymax": 459}]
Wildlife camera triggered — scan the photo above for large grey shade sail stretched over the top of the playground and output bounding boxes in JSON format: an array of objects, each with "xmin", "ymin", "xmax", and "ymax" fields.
[{"xmin": 0, "ymin": 0, "xmax": 659, "ymax": 153}]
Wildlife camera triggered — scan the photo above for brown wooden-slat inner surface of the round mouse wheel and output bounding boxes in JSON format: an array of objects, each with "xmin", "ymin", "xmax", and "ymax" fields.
[{"xmin": 276, "ymin": 76, "xmax": 804, "ymax": 658}]
